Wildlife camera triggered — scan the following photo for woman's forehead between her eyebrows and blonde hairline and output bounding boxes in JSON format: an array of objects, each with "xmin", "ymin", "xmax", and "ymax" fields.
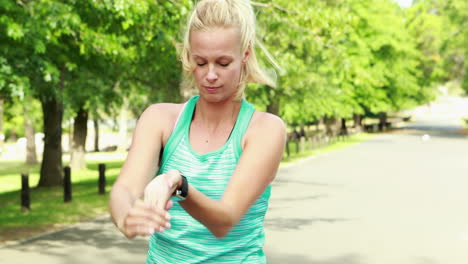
[{"xmin": 190, "ymin": 28, "xmax": 241, "ymax": 57}]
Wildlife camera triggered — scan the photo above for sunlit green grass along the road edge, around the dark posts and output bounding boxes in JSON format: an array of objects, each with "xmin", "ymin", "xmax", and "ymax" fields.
[{"xmin": 0, "ymin": 133, "xmax": 370, "ymax": 243}]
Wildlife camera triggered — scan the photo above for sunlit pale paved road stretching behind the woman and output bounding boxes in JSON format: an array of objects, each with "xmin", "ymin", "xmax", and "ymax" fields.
[{"xmin": 0, "ymin": 97, "xmax": 468, "ymax": 264}]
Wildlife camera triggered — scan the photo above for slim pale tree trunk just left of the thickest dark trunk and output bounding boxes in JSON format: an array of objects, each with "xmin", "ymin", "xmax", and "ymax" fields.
[{"xmin": 23, "ymin": 97, "xmax": 37, "ymax": 164}]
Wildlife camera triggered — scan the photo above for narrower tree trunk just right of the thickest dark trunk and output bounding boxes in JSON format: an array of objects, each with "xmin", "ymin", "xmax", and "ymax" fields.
[{"xmin": 70, "ymin": 106, "xmax": 88, "ymax": 171}]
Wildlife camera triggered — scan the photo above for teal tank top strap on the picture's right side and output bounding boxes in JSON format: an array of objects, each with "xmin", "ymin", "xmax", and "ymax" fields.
[{"xmin": 231, "ymin": 100, "xmax": 255, "ymax": 159}]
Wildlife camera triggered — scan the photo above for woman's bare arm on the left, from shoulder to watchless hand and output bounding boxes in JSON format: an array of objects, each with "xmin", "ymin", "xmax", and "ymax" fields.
[{"xmin": 109, "ymin": 104, "xmax": 173, "ymax": 238}]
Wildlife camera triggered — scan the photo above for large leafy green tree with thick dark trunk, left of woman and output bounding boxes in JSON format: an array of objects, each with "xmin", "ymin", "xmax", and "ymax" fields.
[{"xmin": 0, "ymin": 0, "xmax": 189, "ymax": 179}]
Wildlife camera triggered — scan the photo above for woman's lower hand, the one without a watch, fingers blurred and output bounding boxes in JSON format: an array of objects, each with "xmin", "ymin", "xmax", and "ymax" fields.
[{"xmin": 119, "ymin": 199, "xmax": 173, "ymax": 239}]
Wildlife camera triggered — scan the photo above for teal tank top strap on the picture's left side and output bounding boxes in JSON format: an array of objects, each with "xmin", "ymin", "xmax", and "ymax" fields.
[{"xmin": 160, "ymin": 95, "xmax": 199, "ymax": 169}]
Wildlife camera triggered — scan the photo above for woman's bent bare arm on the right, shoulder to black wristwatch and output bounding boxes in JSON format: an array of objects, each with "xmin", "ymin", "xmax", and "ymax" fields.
[{"xmin": 179, "ymin": 113, "xmax": 286, "ymax": 238}]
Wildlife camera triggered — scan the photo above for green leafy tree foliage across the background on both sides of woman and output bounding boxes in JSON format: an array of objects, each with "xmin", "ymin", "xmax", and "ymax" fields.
[{"xmin": 0, "ymin": 0, "xmax": 462, "ymax": 133}]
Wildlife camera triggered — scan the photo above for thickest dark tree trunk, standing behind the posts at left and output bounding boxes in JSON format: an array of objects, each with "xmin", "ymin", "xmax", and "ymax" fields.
[{"xmin": 38, "ymin": 96, "xmax": 63, "ymax": 187}]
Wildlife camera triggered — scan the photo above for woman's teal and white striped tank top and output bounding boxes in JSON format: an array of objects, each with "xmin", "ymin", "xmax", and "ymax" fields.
[{"xmin": 146, "ymin": 96, "xmax": 271, "ymax": 264}]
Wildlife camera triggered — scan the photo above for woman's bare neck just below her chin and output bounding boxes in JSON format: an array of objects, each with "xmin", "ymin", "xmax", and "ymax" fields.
[{"xmin": 194, "ymin": 97, "xmax": 242, "ymax": 130}]
